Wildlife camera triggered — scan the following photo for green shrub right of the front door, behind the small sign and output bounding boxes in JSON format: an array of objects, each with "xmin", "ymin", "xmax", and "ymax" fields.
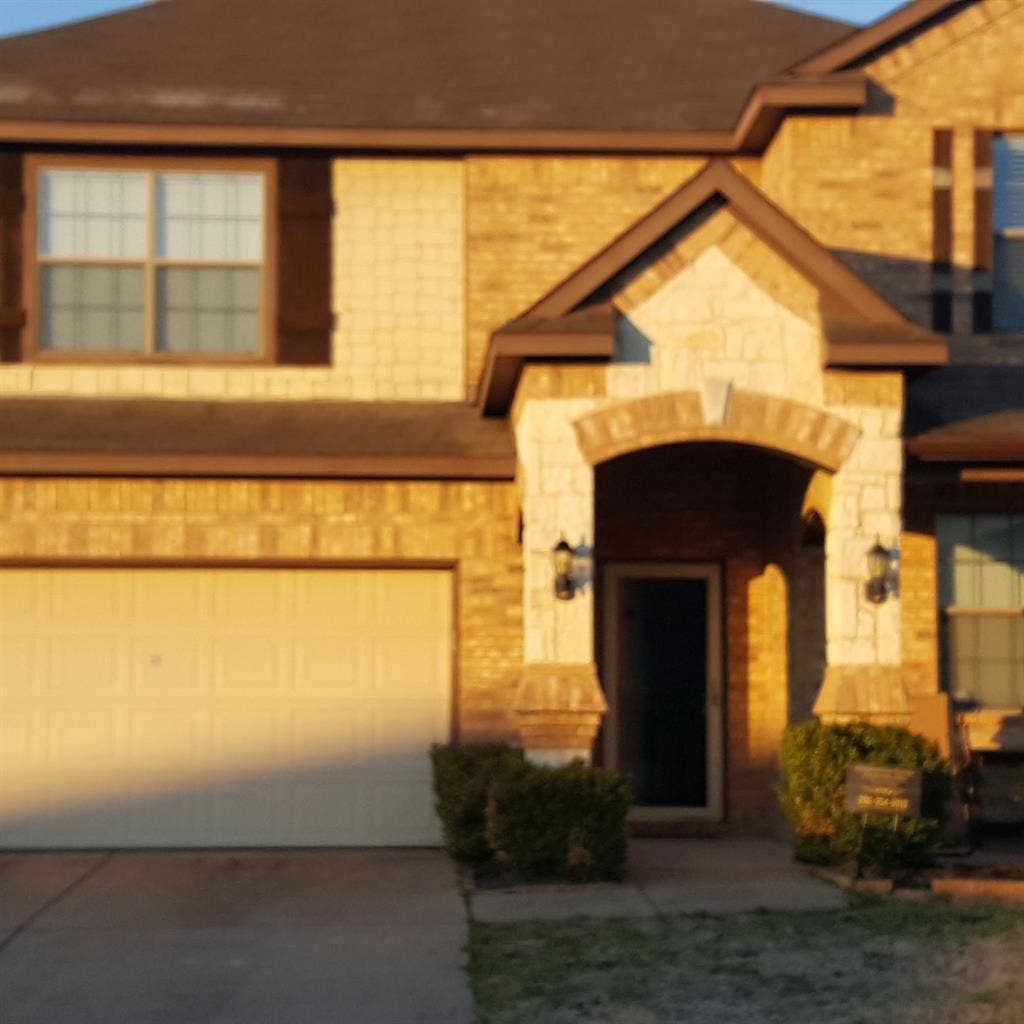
[{"xmin": 779, "ymin": 722, "xmax": 949, "ymax": 873}]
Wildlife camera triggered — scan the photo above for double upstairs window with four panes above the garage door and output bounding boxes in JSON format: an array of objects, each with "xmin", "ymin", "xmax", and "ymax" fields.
[{"xmin": 34, "ymin": 162, "xmax": 269, "ymax": 361}]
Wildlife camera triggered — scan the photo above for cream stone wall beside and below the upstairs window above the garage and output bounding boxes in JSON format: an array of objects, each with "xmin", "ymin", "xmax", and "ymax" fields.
[{"xmin": 0, "ymin": 158, "xmax": 466, "ymax": 401}]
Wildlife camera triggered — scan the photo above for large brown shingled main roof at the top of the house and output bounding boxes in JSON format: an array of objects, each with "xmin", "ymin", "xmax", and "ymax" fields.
[{"xmin": 0, "ymin": 0, "xmax": 852, "ymax": 132}]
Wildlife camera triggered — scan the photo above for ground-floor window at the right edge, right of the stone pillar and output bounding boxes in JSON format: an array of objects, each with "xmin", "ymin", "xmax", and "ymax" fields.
[{"xmin": 936, "ymin": 515, "xmax": 1024, "ymax": 710}]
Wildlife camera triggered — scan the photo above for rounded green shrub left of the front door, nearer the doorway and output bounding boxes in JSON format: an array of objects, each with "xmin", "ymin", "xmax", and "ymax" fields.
[{"xmin": 487, "ymin": 761, "xmax": 633, "ymax": 882}]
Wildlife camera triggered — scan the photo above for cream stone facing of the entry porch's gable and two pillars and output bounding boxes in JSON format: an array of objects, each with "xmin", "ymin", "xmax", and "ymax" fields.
[{"xmin": 514, "ymin": 212, "xmax": 903, "ymax": 704}]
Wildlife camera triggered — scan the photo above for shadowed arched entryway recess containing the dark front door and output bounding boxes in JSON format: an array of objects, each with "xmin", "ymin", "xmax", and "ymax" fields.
[{"xmin": 594, "ymin": 441, "xmax": 825, "ymax": 835}]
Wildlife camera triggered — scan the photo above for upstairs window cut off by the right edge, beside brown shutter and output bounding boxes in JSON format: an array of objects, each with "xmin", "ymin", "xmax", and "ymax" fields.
[{"xmin": 992, "ymin": 135, "xmax": 1024, "ymax": 331}]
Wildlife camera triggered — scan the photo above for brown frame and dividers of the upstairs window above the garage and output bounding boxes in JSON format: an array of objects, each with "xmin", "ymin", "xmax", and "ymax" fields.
[{"xmin": 22, "ymin": 153, "xmax": 279, "ymax": 367}]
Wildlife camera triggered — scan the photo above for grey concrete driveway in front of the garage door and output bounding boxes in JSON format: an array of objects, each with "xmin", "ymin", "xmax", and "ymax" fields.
[{"xmin": 0, "ymin": 850, "xmax": 472, "ymax": 1024}]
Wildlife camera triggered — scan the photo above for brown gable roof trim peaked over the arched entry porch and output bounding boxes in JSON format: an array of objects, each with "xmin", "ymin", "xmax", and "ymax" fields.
[{"xmin": 481, "ymin": 158, "xmax": 947, "ymax": 415}]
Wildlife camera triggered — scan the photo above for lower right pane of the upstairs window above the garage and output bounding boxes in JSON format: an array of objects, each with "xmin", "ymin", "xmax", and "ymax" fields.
[{"xmin": 157, "ymin": 267, "xmax": 260, "ymax": 353}]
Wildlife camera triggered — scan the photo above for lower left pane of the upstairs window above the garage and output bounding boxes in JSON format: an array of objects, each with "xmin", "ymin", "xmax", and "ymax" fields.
[{"xmin": 40, "ymin": 265, "xmax": 144, "ymax": 352}]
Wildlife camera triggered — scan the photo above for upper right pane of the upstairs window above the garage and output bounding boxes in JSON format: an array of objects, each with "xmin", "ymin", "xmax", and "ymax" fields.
[{"xmin": 157, "ymin": 173, "xmax": 263, "ymax": 262}]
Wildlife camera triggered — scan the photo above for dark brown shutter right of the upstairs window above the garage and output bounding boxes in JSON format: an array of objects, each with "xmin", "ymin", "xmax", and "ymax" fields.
[{"xmin": 276, "ymin": 157, "xmax": 334, "ymax": 366}]
